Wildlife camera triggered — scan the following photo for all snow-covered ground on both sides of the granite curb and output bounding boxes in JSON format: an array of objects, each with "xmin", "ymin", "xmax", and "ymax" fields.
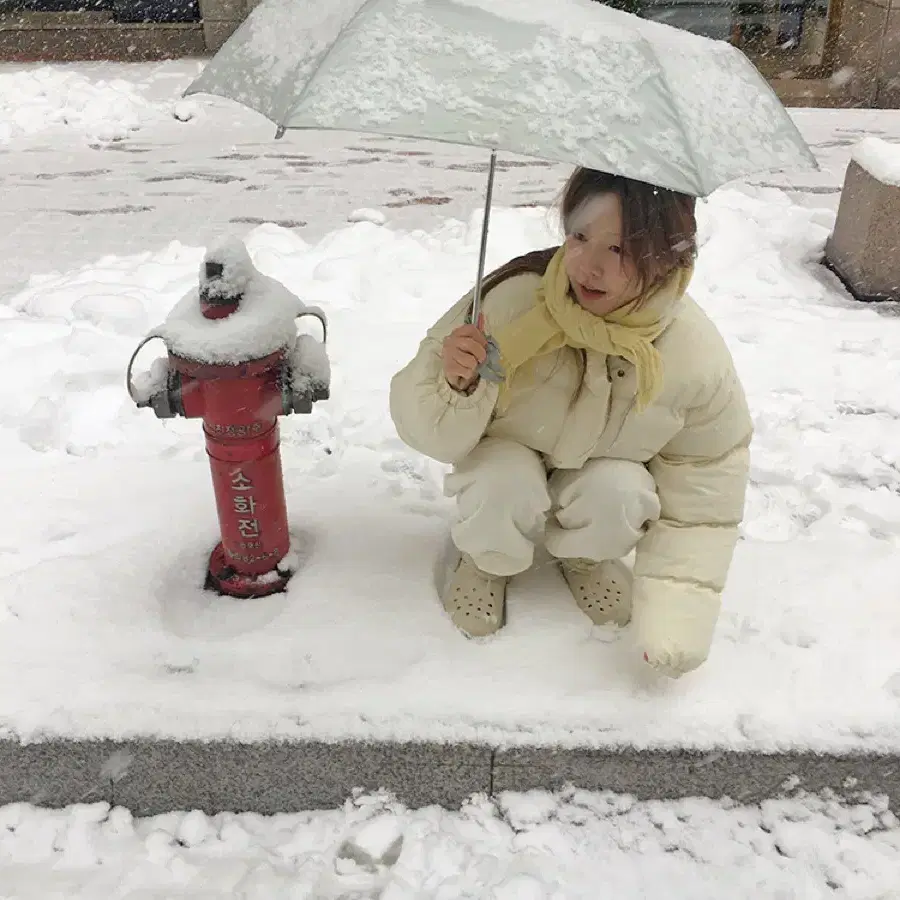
[{"xmin": 0, "ymin": 54, "xmax": 900, "ymax": 900}]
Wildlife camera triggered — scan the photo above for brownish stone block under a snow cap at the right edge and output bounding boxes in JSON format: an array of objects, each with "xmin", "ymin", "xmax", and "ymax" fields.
[{"xmin": 825, "ymin": 157, "xmax": 900, "ymax": 301}]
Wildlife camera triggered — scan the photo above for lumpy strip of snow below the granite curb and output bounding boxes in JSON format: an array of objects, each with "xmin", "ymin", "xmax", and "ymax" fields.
[{"xmin": 0, "ymin": 790, "xmax": 900, "ymax": 900}]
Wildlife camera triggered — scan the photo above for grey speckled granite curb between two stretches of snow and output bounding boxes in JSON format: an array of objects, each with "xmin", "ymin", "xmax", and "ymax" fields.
[{"xmin": 0, "ymin": 739, "xmax": 900, "ymax": 816}]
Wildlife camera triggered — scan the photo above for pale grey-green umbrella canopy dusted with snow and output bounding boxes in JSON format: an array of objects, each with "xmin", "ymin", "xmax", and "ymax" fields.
[{"xmin": 186, "ymin": 0, "xmax": 816, "ymax": 196}]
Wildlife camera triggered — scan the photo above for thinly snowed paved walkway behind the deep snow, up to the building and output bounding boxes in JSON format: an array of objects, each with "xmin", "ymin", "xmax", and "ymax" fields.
[{"xmin": 0, "ymin": 62, "xmax": 900, "ymax": 294}]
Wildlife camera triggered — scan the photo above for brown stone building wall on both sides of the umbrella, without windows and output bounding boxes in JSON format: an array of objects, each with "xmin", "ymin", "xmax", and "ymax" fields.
[{"xmin": 0, "ymin": 0, "xmax": 900, "ymax": 108}]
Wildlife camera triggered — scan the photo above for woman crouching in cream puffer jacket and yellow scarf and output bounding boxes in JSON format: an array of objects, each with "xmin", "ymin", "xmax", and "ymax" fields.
[{"xmin": 390, "ymin": 169, "xmax": 752, "ymax": 677}]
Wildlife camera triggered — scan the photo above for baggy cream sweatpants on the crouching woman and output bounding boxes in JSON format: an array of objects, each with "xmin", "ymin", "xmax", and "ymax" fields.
[{"xmin": 445, "ymin": 437, "xmax": 660, "ymax": 575}]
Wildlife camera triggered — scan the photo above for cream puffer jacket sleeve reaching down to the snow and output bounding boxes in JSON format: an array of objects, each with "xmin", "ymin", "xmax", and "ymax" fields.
[{"xmin": 634, "ymin": 366, "xmax": 753, "ymax": 677}]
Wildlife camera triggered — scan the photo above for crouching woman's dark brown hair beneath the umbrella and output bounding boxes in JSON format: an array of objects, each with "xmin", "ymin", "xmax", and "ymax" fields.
[{"xmin": 559, "ymin": 168, "xmax": 697, "ymax": 289}]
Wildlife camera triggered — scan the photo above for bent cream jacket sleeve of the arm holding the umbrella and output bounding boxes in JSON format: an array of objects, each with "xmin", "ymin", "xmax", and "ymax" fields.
[{"xmin": 390, "ymin": 293, "xmax": 499, "ymax": 463}]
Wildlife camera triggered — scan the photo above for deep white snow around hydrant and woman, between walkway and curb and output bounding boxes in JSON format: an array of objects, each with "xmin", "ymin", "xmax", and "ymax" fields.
[{"xmin": 0, "ymin": 179, "xmax": 900, "ymax": 750}]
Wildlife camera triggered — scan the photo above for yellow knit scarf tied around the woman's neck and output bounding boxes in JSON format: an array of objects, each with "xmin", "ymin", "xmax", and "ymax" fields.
[{"xmin": 494, "ymin": 246, "xmax": 693, "ymax": 410}]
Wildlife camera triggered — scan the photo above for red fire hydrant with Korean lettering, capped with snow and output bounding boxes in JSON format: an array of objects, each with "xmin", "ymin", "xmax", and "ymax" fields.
[{"xmin": 126, "ymin": 241, "xmax": 330, "ymax": 597}]
